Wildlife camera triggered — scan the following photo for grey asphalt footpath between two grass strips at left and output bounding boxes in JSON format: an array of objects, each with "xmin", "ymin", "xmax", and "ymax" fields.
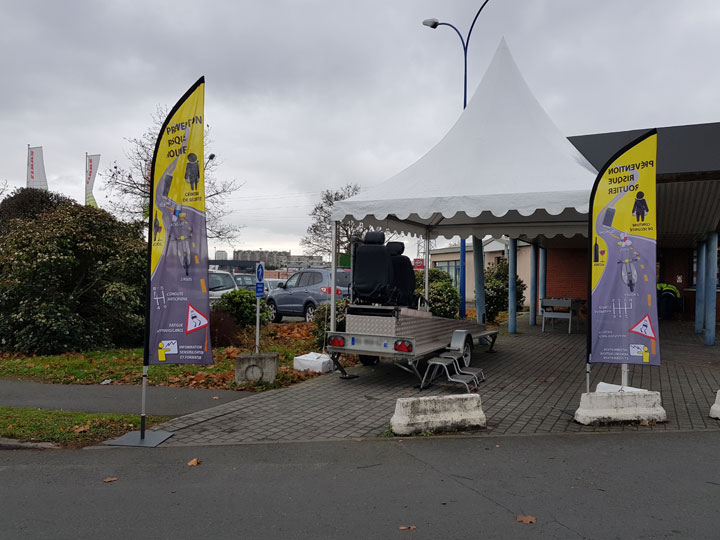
[{"xmin": 0, "ymin": 379, "xmax": 252, "ymax": 416}]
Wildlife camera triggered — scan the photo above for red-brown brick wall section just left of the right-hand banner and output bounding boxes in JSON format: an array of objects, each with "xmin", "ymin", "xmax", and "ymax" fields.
[{"xmin": 545, "ymin": 249, "xmax": 589, "ymax": 300}]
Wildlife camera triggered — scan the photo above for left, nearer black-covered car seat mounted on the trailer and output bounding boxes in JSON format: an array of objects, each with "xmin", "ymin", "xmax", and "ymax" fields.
[{"xmin": 353, "ymin": 231, "xmax": 397, "ymax": 304}]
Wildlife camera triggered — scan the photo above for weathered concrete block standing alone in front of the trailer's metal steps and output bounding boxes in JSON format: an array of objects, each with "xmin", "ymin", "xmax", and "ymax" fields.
[{"xmin": 390, "ymin": 394, "xmax": 487, "ymax": 435}]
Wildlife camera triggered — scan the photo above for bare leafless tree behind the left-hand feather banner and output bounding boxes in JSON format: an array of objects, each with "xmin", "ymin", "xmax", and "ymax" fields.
[{"xmin": 101, "ymin": 106, "xmax": 243, "ymax": 241}]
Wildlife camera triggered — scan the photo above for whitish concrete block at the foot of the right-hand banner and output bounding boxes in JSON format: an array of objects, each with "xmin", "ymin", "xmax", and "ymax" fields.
[{"xmin": 575, "ymin": 392, "xmax": 667, "ymax": 426}]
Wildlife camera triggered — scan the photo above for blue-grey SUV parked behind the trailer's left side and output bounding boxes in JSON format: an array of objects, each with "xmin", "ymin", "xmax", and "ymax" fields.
[{"xmin": 267, "ymin": 268, "xmax": 351, "ymax": 322}]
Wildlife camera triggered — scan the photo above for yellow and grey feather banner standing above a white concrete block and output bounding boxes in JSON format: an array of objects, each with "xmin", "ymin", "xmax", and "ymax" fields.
[{"xmin": 588, "ymin": 130, "xmax": 660, "ymax": 365}]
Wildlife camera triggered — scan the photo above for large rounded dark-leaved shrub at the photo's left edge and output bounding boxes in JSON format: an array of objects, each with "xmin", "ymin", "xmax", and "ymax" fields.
[{"xmin": 0, "ymin": 197, "xmax": 147, "ymax": 354}]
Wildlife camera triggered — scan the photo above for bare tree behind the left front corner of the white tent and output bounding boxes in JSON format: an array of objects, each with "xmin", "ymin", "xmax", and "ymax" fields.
[{"xmin": 300, "ymin": 184, "xmax": 376, "ymax": 256}]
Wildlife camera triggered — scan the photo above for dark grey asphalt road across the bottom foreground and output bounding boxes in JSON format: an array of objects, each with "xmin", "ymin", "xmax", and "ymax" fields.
[{"xmin": 0, "ymin": 432, "xmax": 720, "ymax": 540}]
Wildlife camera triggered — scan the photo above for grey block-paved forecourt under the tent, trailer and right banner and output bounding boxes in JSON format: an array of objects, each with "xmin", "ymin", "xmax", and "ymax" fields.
[{"xmin": 157, "ymin": 318, "xmax": 720, "ymax": 446}]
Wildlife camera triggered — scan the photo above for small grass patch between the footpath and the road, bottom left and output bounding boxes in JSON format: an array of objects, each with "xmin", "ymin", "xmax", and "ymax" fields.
[{"xmin": 0, "ymin": 407, "xmax": 170, "ymax": 448}]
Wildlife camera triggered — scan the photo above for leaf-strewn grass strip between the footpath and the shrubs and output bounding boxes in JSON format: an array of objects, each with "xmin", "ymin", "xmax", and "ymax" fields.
[{"xmin": 0, "ymin": 323, "xmax": 324, "ymax": 391}]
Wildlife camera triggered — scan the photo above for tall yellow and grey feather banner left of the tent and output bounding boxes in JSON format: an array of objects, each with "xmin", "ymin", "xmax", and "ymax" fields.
[{"xmin": 145, "ymin": 77, "xmax": 213, "ymax": 365}]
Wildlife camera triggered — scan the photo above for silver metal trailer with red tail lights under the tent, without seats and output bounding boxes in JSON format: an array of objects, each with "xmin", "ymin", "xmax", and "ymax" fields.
[{"xmin": 327, "ymin": 305, "xmax": 497, "ymax": 381}]
